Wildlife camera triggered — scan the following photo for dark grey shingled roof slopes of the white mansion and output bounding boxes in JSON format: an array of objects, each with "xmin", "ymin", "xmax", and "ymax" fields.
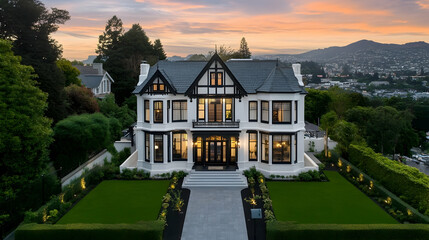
[{"xmin": 133, "ymin": 60, "xmax": 306, "ymax": 94}]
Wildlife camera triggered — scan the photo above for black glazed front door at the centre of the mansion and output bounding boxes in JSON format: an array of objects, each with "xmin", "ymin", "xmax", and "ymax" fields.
[{"xmin": 205, "ymin": 137, "xmax": 227, "ymax": 165}]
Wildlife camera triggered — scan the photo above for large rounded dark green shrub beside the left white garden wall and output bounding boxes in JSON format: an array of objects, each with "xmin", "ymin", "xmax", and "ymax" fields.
[{"xmin": 52, "ymin": 113, "xmax": 112, "ymax": 176}]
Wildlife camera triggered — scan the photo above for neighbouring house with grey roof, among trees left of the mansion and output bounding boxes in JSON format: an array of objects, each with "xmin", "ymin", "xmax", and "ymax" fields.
[{"xmin": 74, "ymin": 63, "xmax": 115, "ymax": 98}]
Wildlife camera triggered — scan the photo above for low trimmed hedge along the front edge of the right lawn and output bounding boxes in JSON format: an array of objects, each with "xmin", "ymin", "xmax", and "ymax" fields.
[{"xmin": 267, "ymin": 222, "xmax": 429, "ymax": 240}]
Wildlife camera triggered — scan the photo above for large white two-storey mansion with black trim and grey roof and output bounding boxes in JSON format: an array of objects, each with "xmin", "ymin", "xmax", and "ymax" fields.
[{"xmin": 121, "ymin": 54, "xmax": 317, "ymax": 175}]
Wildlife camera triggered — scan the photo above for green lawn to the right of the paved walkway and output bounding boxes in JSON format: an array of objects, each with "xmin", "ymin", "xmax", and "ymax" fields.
[{"xmin": 267, "ymin": 171, "xmax": 397, "ymax": 224}]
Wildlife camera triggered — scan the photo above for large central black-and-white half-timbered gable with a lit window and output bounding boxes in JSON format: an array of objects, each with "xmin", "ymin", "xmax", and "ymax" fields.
[{"xmin": 185, "ymin": 53, "xmax": 247, "ymax": 98}]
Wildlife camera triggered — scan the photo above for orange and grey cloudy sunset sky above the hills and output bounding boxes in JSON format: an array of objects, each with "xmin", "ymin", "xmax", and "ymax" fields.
[{"xmin": 42, "ymin": 0, "xmax": 429, "ymax": 60}]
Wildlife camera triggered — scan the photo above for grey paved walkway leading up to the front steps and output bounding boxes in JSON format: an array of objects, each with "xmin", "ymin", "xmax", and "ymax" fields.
[{"xmin": 182, "ymin": 187, "xmax": 248, "ymax": 240}]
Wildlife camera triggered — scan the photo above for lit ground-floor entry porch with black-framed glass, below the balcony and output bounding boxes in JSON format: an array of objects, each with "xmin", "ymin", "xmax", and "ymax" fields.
[{"xmin": 192, "ymin": 131, "xmax": 239, "ymax": 167}]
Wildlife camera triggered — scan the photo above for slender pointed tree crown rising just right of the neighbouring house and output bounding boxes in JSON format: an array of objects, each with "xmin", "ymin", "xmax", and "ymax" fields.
[{"xmin": 95, "ymin": 15, "xmax": 125, "ymax": 60}]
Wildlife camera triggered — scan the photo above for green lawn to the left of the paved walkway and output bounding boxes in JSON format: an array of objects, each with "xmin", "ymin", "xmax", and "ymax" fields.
[{"xmin": 58, "ymin": 180, "xmax": 169, "ymax": 224}]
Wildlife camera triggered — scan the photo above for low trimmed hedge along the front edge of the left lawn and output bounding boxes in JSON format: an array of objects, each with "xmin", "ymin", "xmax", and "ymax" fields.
[{"xmin": 15, "ymin": 221, "xmax": 164, "ymax": 240}]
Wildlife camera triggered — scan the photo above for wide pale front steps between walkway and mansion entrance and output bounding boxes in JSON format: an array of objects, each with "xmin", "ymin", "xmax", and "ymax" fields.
[{"xmin": 182, "ymin": 170, "xmax": 247, "ymax": 188}]
